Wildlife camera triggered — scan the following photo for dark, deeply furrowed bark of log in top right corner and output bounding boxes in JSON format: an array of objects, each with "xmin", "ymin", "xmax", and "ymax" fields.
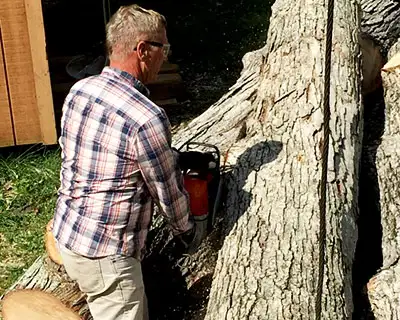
[{"xmin": 360, "ymin": 0, "xmax": 400, "ymax": 55}]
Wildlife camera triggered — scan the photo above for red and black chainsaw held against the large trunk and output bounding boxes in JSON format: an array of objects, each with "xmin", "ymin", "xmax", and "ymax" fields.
[{"xmin": 178, "ymin": 142, "xmax": 222, "ymax": 238}]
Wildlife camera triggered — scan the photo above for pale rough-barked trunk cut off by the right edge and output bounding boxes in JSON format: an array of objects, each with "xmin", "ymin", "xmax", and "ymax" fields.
[{"xmin": 368, "ymin": 41, "xmax": 400, "ymax": 319}]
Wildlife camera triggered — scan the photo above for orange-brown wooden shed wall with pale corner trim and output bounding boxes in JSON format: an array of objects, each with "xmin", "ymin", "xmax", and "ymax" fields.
[{"xmin": 0, "ymin": 0, "xmax": 57, "ymax": 147}]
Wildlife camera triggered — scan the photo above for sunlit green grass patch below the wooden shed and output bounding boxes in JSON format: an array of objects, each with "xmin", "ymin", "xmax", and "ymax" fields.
[{"xmin": 0, "ymin": 149, "xmax": 61, "ymax": 295}]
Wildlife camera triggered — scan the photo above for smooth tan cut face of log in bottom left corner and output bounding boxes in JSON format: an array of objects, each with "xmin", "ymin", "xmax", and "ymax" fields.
[{"xmin": 2, "ymin": 290, "xmax": 81, "ymax": 320}]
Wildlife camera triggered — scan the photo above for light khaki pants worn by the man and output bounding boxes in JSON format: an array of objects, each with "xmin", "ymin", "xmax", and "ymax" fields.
[{"xmin": 60, "ymin": 247, "xmax": 148, "ymax": 320}]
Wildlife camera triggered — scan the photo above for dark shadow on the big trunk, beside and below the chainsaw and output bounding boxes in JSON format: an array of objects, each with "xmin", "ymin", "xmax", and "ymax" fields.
[{"xmin": 142, "ymin": 141, "xmax": 282, "ymax": 320}]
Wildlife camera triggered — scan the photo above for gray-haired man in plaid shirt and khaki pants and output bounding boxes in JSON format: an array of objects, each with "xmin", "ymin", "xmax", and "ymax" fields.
[{"xmin": 53, "ymin": 5, "xmax": 199, "ymax": 320}]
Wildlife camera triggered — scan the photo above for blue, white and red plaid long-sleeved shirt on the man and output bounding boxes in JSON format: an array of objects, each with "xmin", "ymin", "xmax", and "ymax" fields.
[{"xmin": 53, "ymin": 67, "xmax": 192, "ymax": 259}]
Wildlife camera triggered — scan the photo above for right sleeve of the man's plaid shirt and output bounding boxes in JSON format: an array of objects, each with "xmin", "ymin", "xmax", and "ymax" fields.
[{"xmin": 136, "ymin": 114, "xmax": 193, "ymax": 235}]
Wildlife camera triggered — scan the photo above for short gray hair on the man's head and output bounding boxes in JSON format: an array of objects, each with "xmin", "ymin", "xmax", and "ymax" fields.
[{"xmin": 106, "ymin": 4, "xmax": 167, "ymax": 59}]
